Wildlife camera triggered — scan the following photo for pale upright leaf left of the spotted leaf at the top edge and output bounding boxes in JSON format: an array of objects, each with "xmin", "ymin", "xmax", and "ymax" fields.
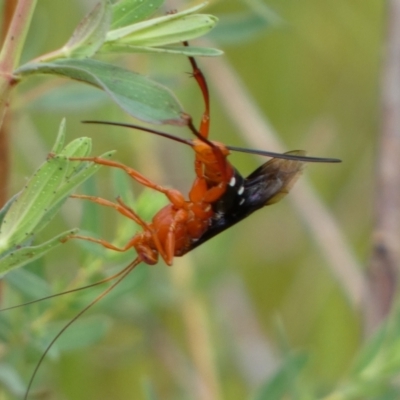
[{"xmin": 62, "ymin": 0, "xmax": 112, "ymax": 58}]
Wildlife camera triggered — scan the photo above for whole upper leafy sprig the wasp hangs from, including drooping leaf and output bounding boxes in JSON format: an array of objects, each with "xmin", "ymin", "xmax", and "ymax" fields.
[{"xmin": 3, "ymin": 0, "xmax": 221, "ymax": 125}]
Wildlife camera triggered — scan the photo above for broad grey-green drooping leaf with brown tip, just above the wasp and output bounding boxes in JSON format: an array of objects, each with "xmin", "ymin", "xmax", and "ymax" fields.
[{"xmin": 15, "ymin": 59, "xmax": 187, "ymax": 125}]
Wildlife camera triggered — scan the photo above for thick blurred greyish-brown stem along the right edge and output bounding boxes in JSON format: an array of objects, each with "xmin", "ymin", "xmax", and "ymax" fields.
[{"xmin": 367, "ymin": 0, "xmax": 400, "ymax": 329}]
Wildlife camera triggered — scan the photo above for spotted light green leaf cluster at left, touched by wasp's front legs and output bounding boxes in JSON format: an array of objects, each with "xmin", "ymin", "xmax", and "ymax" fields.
[{"xmin": 0, "ymin": 121, "xmax": 113, "ymax": 274}]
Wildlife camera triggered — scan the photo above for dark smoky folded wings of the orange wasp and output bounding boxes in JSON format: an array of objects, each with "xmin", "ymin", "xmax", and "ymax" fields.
[{"xmin": 189, "ymin": 150, "xmax": 305, "ymax": 250}]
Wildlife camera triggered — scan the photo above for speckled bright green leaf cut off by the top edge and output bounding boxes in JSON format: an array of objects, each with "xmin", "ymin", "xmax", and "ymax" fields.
[{"xmin": 111, "ymin": 0, "xmax": 164, "ymax": 29}]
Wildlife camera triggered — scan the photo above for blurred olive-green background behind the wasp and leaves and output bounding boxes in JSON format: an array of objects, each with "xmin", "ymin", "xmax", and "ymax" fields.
[{"xmin": 0, "ymin": 0, "xmax": 388, "ymax": 400}]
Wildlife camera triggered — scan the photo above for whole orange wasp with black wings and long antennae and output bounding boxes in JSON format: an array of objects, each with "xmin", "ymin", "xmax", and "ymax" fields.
[{"xmin": 17, "ymin": 51, "xmax": 340, "ymax": 399}]
